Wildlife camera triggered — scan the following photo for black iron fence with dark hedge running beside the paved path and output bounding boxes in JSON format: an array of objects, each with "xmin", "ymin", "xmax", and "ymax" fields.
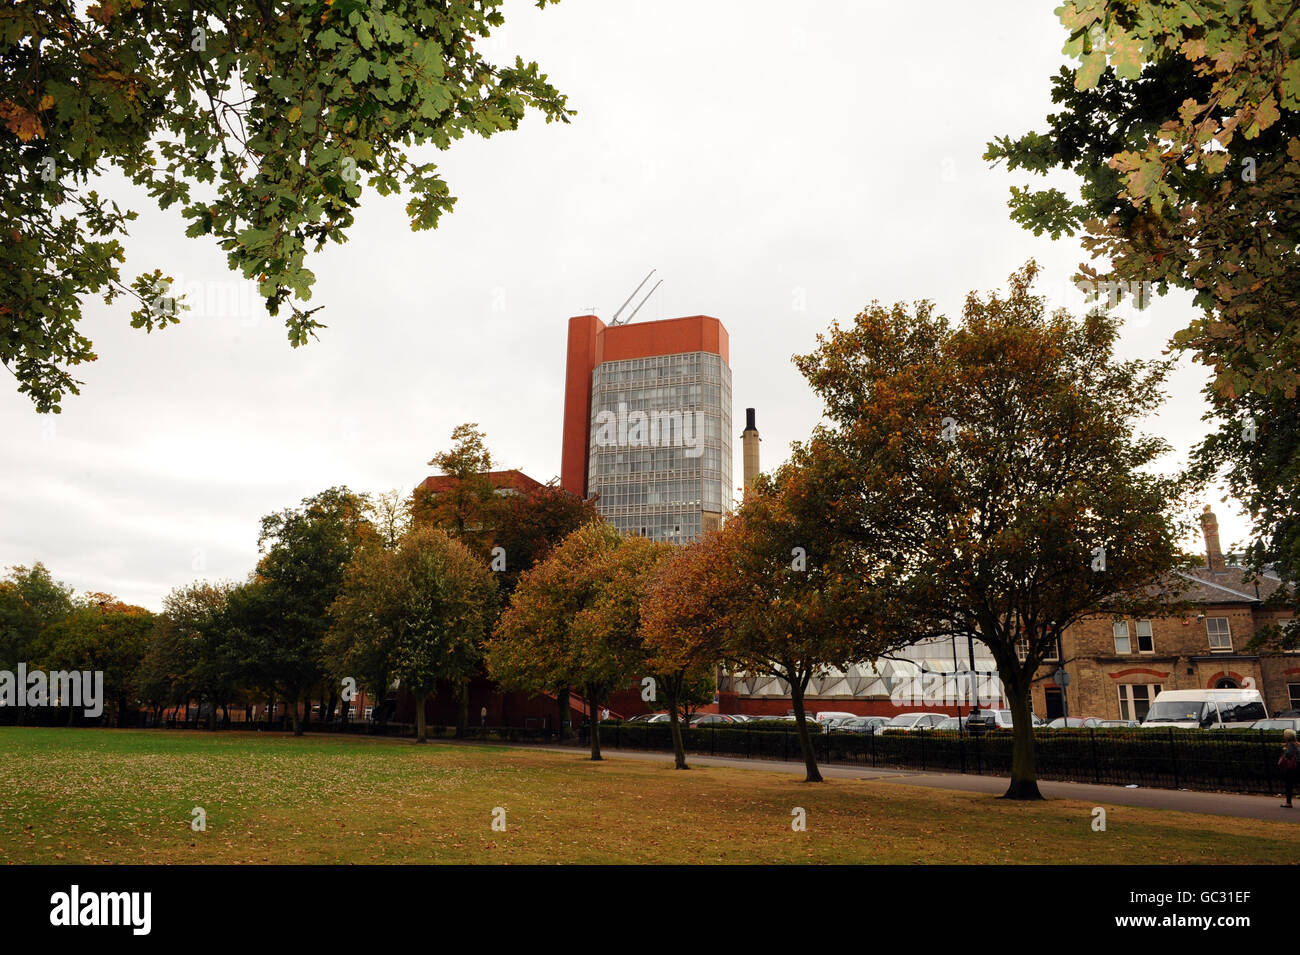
[{"xmin": 580, "ymin": 722, "xmax": 1300, "ymax": 793}]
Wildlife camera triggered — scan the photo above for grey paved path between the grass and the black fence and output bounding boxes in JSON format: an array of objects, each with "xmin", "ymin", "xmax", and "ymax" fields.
[{"xmin": 486, "ymin": 739, "xmax": 1300, "ymax": 822}]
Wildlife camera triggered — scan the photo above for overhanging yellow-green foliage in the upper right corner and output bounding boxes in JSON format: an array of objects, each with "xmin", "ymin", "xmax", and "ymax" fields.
[{"xmin": 987, "ymin": 0, "xmax": 1300, "ymax": 613}]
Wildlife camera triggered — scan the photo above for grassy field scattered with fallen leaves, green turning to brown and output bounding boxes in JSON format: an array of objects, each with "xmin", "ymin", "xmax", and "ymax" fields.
[{"xmin": 0, "ymin": 728, "xmax": 1300, "ymax": 864}]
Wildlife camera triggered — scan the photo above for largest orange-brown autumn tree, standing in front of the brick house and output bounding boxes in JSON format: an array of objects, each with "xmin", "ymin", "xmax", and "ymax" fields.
[{"xmin": 793, "ymin": 262, "xmax": 1183, "ymax": 799}]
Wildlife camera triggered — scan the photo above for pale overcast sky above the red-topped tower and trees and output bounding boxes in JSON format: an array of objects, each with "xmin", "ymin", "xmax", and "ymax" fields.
[{"xmin": 0, "ymin": 0, "xmax": 1248, "ymax": 609}]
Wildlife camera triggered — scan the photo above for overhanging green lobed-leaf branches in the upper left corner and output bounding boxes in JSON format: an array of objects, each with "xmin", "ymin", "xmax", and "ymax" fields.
[{"xmin": 0, "ymin": 0, "xmax": 571, "ymax": 411}]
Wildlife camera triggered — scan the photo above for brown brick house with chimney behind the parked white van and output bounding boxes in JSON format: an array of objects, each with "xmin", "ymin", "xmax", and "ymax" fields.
[{"xmin": 1034, "ymin": 507, "xmax": 1300, "ymax": 720}]
